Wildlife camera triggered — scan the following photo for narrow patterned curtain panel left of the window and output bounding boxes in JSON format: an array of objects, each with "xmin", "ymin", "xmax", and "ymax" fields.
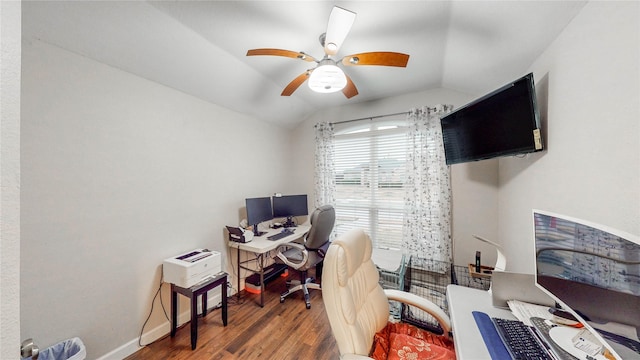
[{"xmin": 315, "ymin": 122, "xmax": 336, "ymax": 208}]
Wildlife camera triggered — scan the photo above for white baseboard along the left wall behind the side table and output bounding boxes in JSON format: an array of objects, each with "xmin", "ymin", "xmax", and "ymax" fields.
[{"xmin": 97, "ymin": 291, "xmax": 222, "ymax": 360}]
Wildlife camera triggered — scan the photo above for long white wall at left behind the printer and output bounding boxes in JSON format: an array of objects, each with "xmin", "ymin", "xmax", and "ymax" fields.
[{"xmin": 20, "ymin": 41, "xmax": 290, "ymax": 359}]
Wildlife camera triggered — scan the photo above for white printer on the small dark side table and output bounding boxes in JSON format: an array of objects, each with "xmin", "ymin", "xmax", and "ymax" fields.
[{"xmin": 162, "ymin": 249, "xmax": 222, "ymax": 288}]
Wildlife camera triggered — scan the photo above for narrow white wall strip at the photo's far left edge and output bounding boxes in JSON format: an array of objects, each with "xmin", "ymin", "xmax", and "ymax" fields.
[{"xmin": 0, "ymin": 1, "xmax": 22, "ymax": 359}]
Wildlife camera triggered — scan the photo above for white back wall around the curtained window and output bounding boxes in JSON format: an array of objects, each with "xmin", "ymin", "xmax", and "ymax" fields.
[{"xmin": 292, "ymin": 89, "xmax": 498, "ymax": 265}]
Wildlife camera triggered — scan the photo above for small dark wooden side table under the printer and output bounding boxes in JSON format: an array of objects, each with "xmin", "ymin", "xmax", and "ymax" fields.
[{"xmin": 171, "ymin": 272, "xmax": 227, "ymax": 350}]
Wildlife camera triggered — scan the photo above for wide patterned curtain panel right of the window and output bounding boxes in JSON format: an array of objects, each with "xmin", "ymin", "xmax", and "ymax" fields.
[{"xmin": 402, "ymin": 105, "xmax": 453, "ymax": 271}]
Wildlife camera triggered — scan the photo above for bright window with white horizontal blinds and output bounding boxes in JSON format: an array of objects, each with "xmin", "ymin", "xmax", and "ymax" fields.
[{"xmin": 334, "ymin": 120, "xmax": 407, "ymax": 249}]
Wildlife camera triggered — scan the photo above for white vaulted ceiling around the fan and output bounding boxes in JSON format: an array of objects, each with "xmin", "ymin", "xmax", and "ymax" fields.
[{"xmin": 22, "ymin": 1, "xmax": 585, "ymax": 127}]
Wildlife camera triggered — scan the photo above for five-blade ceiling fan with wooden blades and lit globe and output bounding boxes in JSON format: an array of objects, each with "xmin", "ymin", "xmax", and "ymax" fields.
[{"xmin": 247, "ymin": 6, "xmax": 409, "ymax": 99}]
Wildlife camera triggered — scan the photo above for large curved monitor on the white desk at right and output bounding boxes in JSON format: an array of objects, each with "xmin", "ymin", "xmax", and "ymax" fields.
[{"xmin": 533, "ymin": 210, "xmax": 640, "ymax": 359}]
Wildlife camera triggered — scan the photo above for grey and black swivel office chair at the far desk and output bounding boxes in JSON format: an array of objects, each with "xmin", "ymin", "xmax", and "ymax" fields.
[{"xmin": 276, "ymin": 205, "xmax": 336, "ymax": 309}]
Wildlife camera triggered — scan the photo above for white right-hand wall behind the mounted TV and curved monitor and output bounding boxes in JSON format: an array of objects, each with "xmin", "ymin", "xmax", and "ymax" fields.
[{"xmin": 499, "ymin": 2, "xmax": 640, "ymax": 272}]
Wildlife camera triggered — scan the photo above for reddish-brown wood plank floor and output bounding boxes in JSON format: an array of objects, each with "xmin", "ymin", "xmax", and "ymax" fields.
[{"xmin": 126, "ymin": 275, "xmax": 339, "ymax": 360}]
